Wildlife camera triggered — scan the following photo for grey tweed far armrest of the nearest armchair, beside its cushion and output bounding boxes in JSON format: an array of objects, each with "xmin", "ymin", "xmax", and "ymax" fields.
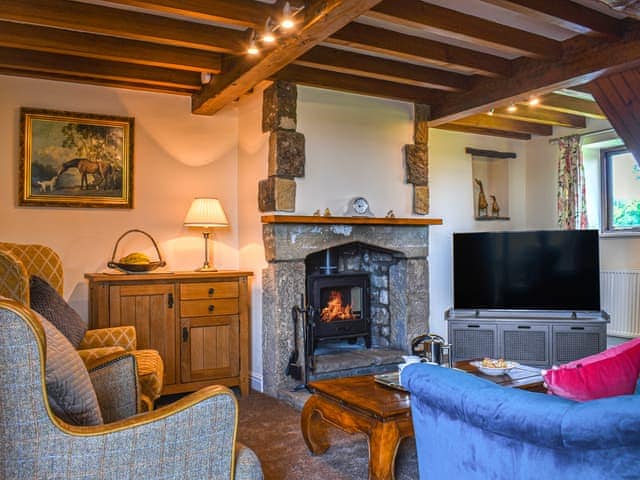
[{"xmin": 87, "ymin": 351, "xmax": 140, "ymax": 423}]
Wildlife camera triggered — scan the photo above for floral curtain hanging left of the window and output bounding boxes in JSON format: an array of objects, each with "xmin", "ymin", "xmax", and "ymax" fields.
[{"xmin": 558, "ymin": 135, "xmax": 587, "ymax": 230}]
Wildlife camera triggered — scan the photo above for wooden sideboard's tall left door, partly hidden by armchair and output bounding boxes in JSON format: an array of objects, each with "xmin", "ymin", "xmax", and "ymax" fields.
[{"xmin": 109, "ymin": 284, "xmax": 176, "ymax": 385}]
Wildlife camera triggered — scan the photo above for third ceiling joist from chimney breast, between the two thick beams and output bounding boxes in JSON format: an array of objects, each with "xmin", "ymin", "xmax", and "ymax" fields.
[{"xmin": 326, "ymin": 23, "xmax": 510, "ymax": 76}]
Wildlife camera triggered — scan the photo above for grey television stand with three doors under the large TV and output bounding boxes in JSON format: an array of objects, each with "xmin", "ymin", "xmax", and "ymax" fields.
[{"xmin": 445, "ymin": 309, "xmax": 609, "ymax": 368}]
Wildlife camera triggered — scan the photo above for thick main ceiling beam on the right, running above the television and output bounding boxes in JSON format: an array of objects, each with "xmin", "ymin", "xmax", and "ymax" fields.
[{"xmin": 430, "ymin": 26, "xmax": 640, "ymax": 125}]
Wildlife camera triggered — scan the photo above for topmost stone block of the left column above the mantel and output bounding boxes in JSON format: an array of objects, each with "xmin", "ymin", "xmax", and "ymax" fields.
[{"xmin": 262, "ymin": 80, "xmax": 298, "ymax": 132}]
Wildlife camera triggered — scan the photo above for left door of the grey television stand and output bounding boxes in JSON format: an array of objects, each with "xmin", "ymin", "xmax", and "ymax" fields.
[{"xmin": 449, "ymin": 322, "xmax": 498, "ymax": 362}]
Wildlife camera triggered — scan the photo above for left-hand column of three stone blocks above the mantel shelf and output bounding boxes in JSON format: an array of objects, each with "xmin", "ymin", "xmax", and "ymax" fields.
[{"xmin": 258, "ymin": 80, "xmax": 305, "ymax": 212}]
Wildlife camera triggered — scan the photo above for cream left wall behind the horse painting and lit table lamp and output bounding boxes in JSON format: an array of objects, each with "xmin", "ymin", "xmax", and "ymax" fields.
[{"xmin": 0, "ymin": 76, "xmax": 239, "ymax": 318}]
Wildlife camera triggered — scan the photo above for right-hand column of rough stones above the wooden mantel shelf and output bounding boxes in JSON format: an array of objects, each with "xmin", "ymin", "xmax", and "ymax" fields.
[{"xmin": 404, "ymin": 103, "xmax": 431, "ymax": 215}]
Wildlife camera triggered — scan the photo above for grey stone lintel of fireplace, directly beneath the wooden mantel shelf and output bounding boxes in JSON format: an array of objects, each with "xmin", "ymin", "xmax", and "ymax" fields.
[{"xmin": 262, "ymin": 223, "xmax": 429, "ymax": 262}]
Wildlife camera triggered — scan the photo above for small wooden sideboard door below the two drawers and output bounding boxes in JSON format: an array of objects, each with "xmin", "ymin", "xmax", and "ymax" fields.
[{"xmin": 180, "ymin": 315, "xmax": 240, "ymax": 382}]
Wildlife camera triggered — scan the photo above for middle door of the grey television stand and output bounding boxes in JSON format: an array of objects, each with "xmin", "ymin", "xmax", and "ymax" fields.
[{"xmin": 498, "ymin": 323, "xmax": 551, "ymax": 367}]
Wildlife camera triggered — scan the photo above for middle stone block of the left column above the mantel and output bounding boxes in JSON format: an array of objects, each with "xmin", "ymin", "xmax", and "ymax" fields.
[{"xmin": 269, "ymin": 129, "xmax": 305, "ymax": 178}]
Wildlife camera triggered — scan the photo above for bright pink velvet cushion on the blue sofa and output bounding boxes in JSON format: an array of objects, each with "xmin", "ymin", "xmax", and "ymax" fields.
[{"xmin": 544, "ymin": 338, "xmax": 640, "ymax": 402}]
